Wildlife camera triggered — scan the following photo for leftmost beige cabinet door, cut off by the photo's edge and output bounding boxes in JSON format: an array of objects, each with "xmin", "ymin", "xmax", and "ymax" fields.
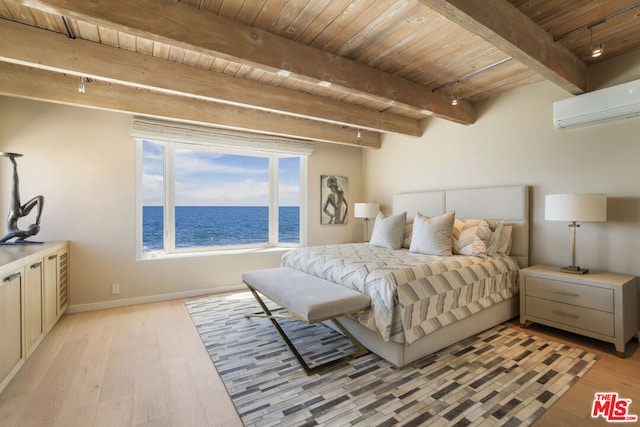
[{"xmin": 0, "ymin": 270, "xmax": 23, "ymax": 384}]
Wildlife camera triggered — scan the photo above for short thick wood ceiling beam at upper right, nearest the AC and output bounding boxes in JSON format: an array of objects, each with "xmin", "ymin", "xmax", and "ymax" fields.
[{"xmin": 420, "ymin": 0, "xmax": 588, "ymax": 94}]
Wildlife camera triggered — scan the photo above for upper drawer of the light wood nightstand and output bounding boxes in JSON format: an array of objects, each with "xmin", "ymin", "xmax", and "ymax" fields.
[{"xmin": 524, "ymin": 276, "xmax": 613, "ymax": 313}]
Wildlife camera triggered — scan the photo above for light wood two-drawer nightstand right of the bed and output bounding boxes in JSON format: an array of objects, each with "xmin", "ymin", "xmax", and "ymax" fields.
[{"xmin": 520, "ymin": 265, "xmax": 638, "ymax": 357}]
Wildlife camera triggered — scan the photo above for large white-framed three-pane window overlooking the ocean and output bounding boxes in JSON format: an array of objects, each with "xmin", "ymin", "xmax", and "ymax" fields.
[{"xmin": 137, "ymin": 118, "xmax": 307, "ymax": 258}]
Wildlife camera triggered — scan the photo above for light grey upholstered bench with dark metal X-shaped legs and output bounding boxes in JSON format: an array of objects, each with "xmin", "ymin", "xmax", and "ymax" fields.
[{"xmin": 242, "ymin": 267, "xmax": 371, "ymax": 375}]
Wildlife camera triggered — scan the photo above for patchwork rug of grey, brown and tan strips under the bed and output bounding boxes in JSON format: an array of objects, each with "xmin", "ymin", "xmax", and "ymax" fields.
[{"xmin": 185, "ymin": 292, "xmax": 598, "ymax": 426}]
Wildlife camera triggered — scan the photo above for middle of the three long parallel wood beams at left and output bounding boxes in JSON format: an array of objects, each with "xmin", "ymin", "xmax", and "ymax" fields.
[{"xmin": 0, "ymin": 20, "xmax": 422, "ymax": 136}]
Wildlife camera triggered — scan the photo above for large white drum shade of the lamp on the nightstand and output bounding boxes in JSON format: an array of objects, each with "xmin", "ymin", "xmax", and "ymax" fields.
[{"xmin": 544, "ymin": 194, "xmax": 607, "ymax": 222}]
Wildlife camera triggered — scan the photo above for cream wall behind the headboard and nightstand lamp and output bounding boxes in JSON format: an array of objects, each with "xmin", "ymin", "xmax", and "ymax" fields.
[{"xmin": 364, "ymin": 52, "xmax": 640, "ymax": 328}]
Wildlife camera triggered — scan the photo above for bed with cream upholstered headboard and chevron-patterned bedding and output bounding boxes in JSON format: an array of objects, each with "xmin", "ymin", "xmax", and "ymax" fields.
[{"xmin": 281, "ymin": 186, "xmax": 529, "ymax": 367}]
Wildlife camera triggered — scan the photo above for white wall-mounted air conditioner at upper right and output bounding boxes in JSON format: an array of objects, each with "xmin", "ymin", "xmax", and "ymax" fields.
[{"xmin": 553, "ymin": 80, "xmax": 640, "ymax": 129}]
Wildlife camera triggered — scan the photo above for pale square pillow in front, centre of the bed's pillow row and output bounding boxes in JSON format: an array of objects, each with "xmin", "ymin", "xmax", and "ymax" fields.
[{"xmin": 409, "ymin": 212, "xmax": 455, "ymax": 256}]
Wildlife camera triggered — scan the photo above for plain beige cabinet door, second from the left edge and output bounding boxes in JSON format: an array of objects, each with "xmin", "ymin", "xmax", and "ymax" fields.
[{"xmin": 24, "ymin": 261, "xmax": 43, "ymax": 357}]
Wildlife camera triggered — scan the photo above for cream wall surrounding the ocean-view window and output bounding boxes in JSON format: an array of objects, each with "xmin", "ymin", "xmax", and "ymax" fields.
[{"xmin": 0, "ymin": 97, "xmax": 362, "ymax": 310}]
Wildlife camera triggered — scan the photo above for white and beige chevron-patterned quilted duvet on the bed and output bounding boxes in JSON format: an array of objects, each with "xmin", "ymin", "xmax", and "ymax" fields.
[{"xmin": 281, "ymin": 243, "xmax": 519, "ymax": 344}]
